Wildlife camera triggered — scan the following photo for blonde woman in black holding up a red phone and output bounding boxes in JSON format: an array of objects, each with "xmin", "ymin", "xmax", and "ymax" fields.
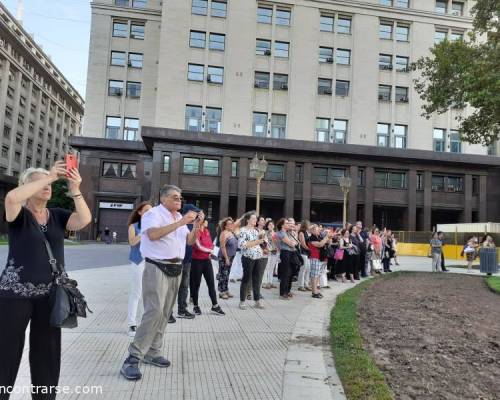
[{"xmin": 0, "ymin": 161, "xmax": 92, "ymax": 399}]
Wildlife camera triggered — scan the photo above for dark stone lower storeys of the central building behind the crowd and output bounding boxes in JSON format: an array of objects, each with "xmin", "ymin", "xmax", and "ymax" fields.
[{"xmin": 71, "ymin": 127, "xmax": 500, "ymax": 240}]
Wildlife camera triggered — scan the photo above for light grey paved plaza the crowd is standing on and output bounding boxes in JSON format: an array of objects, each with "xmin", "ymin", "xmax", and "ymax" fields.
[{"xmin": 0, "ymin": 246, "xmax": 496, "ymax": 400}]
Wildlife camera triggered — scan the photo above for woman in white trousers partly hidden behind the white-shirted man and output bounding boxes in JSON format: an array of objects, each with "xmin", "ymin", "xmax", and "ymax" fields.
[{"xmin": 127, "ymin": 201, "xmax": 153, "ymax": 337}]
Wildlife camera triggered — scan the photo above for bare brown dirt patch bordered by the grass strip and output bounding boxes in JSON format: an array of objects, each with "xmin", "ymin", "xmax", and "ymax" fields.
[{"xmin": 358, "ymin": 273, "xmax": 500, "ymax": 400}]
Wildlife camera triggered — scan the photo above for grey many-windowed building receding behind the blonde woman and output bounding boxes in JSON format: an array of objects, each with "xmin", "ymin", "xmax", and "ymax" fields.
[{"xmin": 0, "ymin": 3, "xmax": 84, "ymax": 177}]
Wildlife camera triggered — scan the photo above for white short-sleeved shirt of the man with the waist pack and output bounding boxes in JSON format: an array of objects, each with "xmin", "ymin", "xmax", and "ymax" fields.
[{"xmin": 141, "ymin": 204, "xmax": 189, "ymax": 260}]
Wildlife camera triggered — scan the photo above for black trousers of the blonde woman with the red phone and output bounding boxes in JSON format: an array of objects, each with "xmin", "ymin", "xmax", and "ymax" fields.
[{"xmin": 0, "ymin": 297, "xmax": 61, "ymax": 400}]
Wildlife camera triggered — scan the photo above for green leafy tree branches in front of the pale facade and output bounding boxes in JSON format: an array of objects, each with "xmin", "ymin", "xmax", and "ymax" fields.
[{"xmin": 413, "ymin": 0, "xmax": 500, "ymax": 146}]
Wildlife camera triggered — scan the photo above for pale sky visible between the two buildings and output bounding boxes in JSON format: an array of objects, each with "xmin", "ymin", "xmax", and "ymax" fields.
[{"xmin": 0, "ymin": 0, "xmax": 90, "ymax": 99}]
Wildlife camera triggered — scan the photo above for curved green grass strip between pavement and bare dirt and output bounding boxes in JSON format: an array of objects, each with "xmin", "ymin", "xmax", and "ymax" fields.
[{"xmin": 330, "ymin": 279, "xmax": 394, "ymax": 400}]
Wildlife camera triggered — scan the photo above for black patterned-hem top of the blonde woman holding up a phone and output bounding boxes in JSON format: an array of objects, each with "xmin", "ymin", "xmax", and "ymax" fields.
[{"xmin": 0, "ymin": 207, "xmax": 72, "ymax": 298}]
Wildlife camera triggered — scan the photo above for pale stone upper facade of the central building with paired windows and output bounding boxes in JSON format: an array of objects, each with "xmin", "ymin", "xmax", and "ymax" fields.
[{"xmin": 84, "ymin": 0, "xmax": 487, "ymax": 154}]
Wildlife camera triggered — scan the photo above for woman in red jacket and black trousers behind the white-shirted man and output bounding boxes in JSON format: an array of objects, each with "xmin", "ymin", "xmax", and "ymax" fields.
[{"xmin": 189, "ymin": 214, "xmax": 226, "ymax": 315}]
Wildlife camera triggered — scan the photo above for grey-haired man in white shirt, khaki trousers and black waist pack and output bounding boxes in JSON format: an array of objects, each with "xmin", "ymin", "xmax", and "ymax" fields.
[{"xmin": 120, "ymin": 185, "xmax": 203, "ymax": 380}]
